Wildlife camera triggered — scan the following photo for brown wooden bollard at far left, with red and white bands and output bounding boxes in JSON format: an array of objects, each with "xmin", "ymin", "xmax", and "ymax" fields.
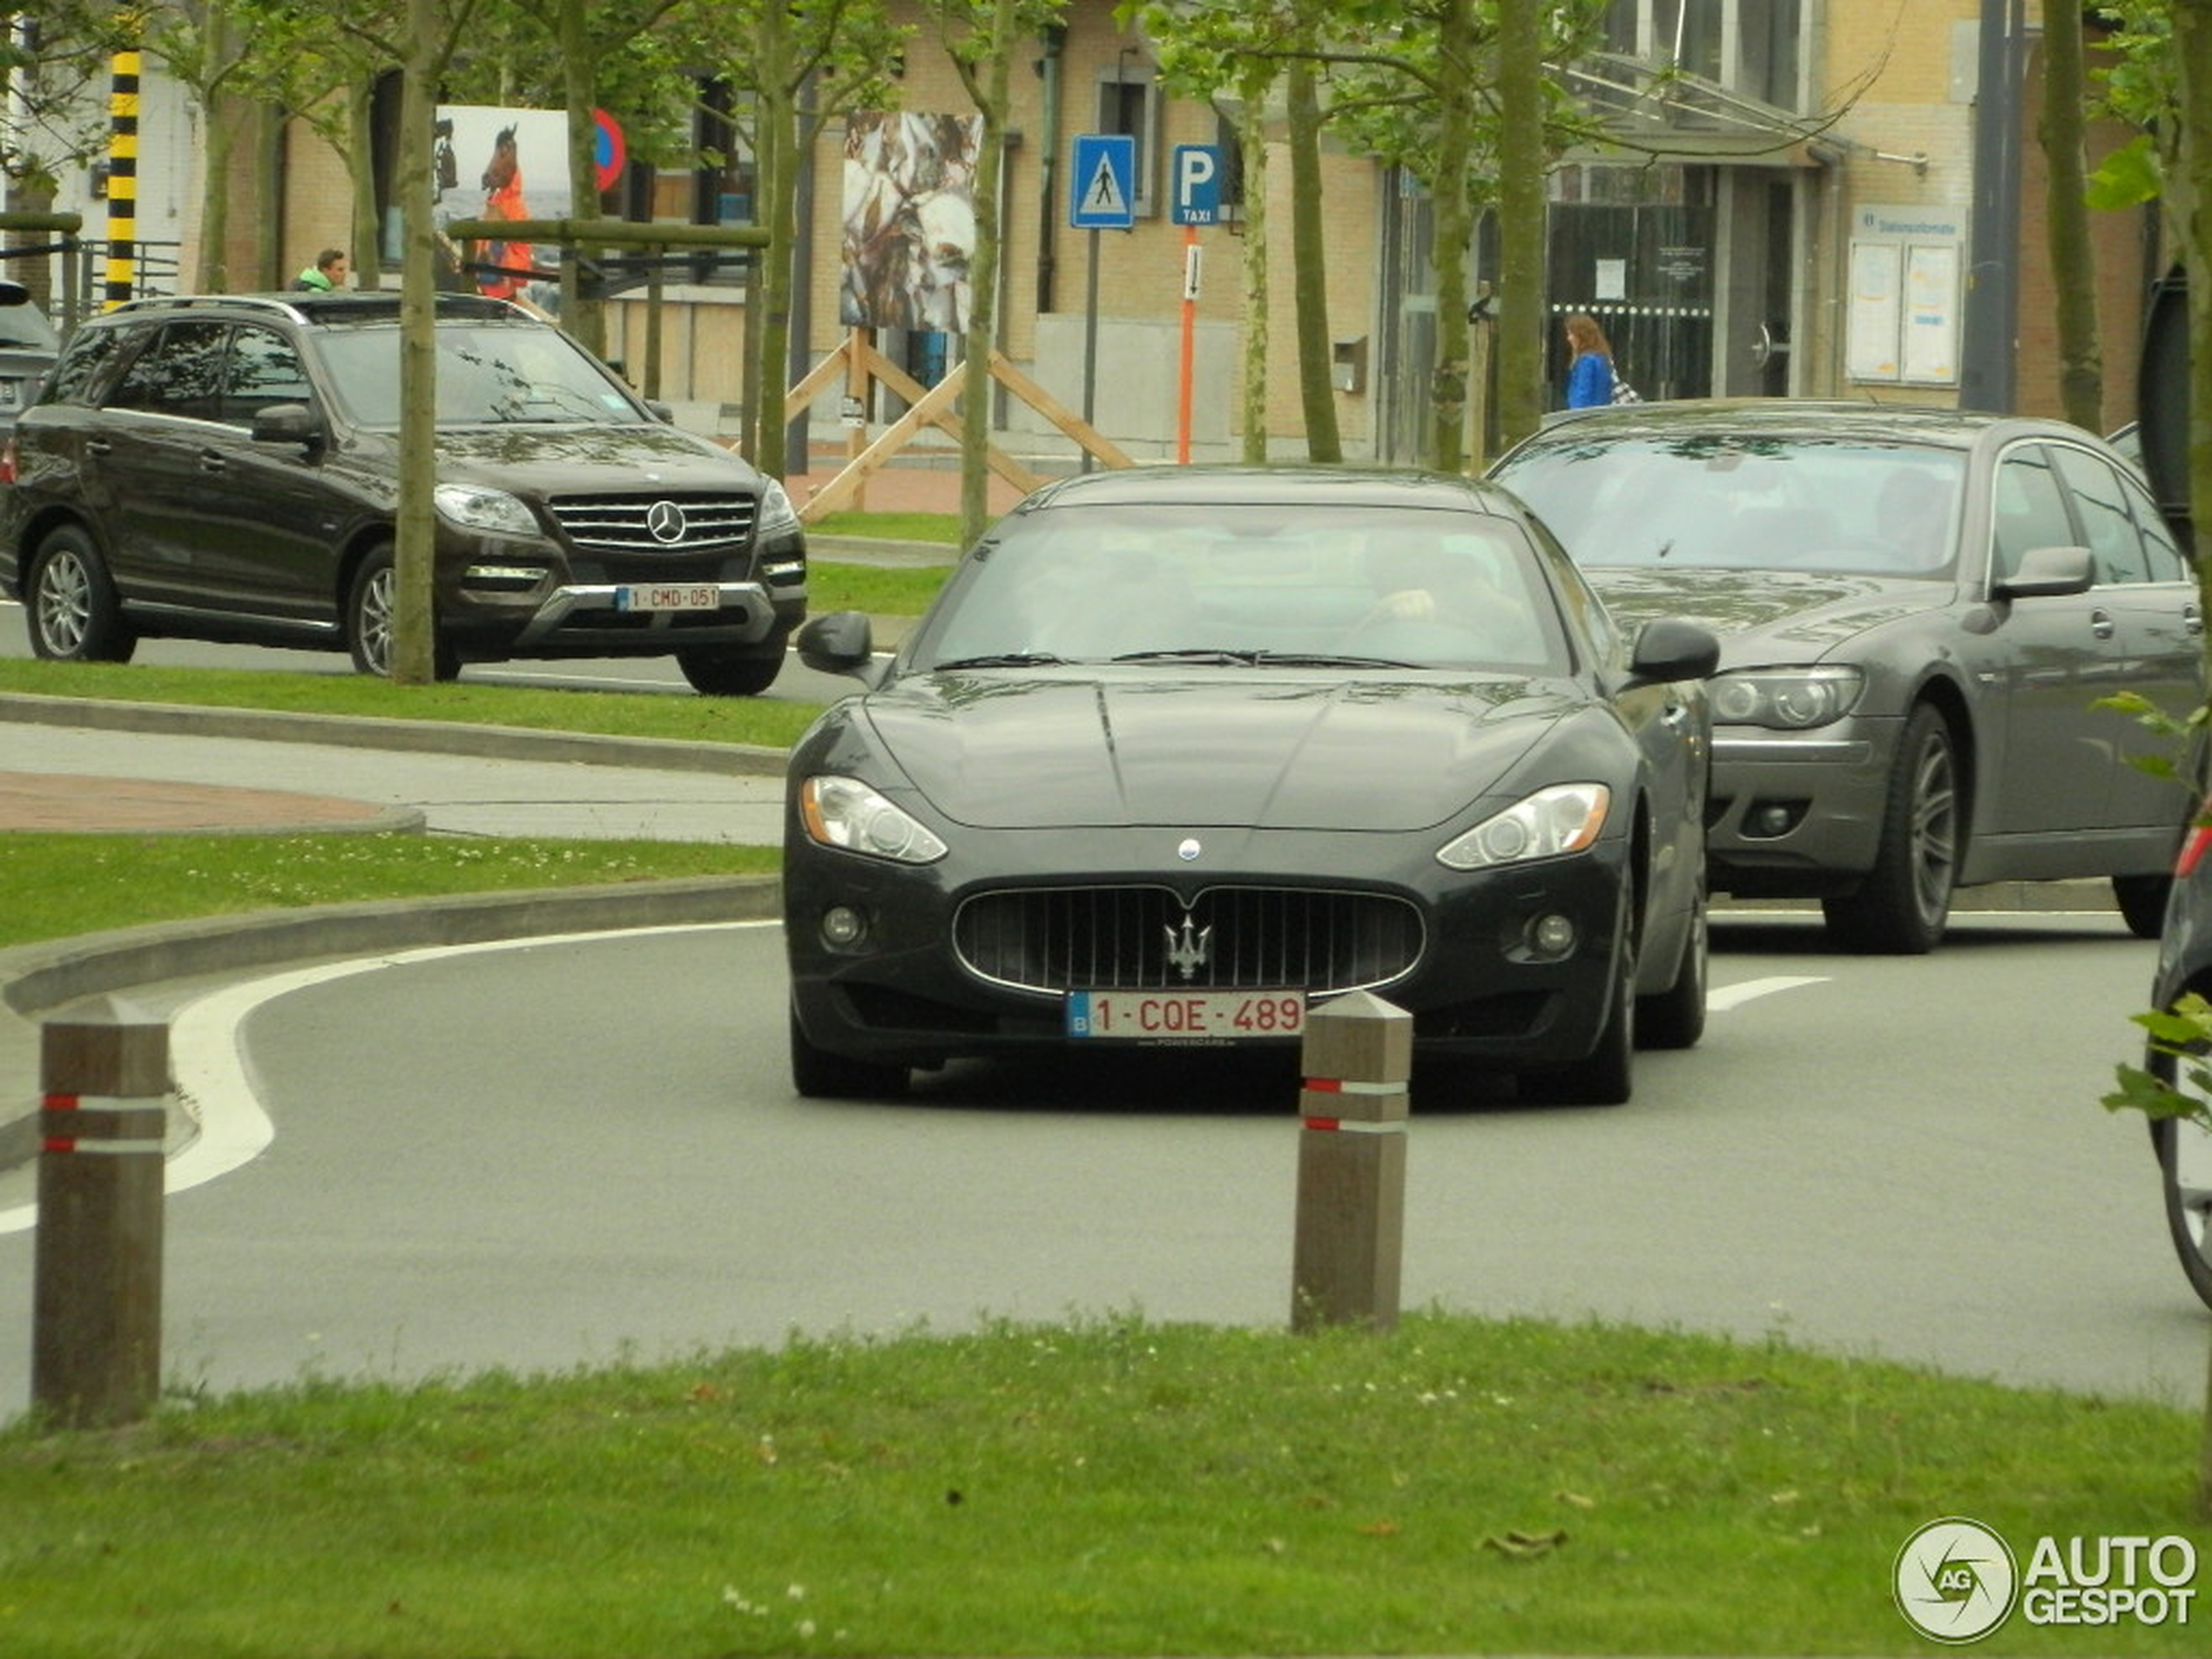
[{"xmin": 31, "ymin": 1004, "xmax": 168, "ymax": 1429}]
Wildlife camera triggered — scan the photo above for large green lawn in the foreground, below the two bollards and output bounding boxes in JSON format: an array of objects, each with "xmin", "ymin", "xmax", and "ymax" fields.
[{"xmin": 0, "ymin": 1316, "xmax": 2212, "ymax": 1659}]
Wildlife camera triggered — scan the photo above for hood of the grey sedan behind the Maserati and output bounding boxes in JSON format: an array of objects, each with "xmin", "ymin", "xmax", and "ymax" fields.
[{"xmin": 1584, "ymin": 564, "xmax": 1958, "ymax": 661}]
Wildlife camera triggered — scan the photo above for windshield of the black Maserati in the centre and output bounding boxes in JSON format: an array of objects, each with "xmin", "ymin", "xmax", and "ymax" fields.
[{"xmin": 914, "ymin": 502, "xmax": 1568, "ymax": 672}]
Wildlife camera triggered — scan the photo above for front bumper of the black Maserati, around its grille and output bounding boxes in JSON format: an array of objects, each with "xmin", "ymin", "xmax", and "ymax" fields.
[{"xmin": 783, "ymin": 830, "xmax": 1626, "ymax": 1070}]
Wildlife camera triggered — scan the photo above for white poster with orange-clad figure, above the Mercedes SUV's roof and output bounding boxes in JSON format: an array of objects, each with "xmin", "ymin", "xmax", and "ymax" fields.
[{"xmin": 431, "ymin": 104, "xmax": 569, "ymax": 314}]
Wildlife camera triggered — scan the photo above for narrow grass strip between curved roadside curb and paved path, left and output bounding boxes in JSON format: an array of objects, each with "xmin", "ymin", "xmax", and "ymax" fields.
[{"xmin": 0, "ymin": 832, "xmax": 783, "ymax": 955}]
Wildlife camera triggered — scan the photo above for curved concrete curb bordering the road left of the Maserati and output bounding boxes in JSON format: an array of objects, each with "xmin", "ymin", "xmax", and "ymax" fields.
[{"xmin": 0, "ymin": 876, "xmax": 783, "ymax": 1170}]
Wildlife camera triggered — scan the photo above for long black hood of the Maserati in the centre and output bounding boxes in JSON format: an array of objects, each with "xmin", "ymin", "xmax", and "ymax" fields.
[{"xmin": 865, "ymin": 671, "xmax": 1580, "ymax": 830}]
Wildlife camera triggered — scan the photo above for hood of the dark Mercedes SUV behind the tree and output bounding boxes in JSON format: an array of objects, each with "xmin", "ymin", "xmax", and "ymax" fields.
[{"xmin": 415, "ymin": 422, "xmax": 759, "ymax": 496}]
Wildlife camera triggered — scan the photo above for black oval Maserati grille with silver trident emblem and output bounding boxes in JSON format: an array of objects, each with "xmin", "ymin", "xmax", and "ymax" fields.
[{"xmin": 954, "ymin": 887, "xmax": 1422, "ymax": 995}]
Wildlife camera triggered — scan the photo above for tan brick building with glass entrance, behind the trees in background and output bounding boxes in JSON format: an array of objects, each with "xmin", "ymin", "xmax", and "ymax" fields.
[{"xmin": 21, "ymin": 0, "xmax": 2161, "ymax": 462}]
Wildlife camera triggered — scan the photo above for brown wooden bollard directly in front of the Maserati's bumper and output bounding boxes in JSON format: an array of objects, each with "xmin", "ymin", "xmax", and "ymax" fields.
[{"xmin": 1290, "ymin": 991, "xmax": 1413, "ymax": 1332}]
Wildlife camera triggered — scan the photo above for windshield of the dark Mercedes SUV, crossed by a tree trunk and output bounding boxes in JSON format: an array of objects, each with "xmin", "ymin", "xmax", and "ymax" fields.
[{"xmin": 312, "ymin": 323, "xmax": 644, "ymax": 431}]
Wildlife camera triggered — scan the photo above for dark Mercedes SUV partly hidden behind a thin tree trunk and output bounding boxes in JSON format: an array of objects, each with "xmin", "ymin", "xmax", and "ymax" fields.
[{"xmin": 0, "ymin": 292, "xmax": 807, "ymax": 695}]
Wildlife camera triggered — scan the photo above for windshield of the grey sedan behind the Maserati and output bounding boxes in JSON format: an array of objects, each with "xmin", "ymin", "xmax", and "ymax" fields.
[{"xmin": 1495, "ymin": 434, "xmax": 1966, "ymax": 577}]
